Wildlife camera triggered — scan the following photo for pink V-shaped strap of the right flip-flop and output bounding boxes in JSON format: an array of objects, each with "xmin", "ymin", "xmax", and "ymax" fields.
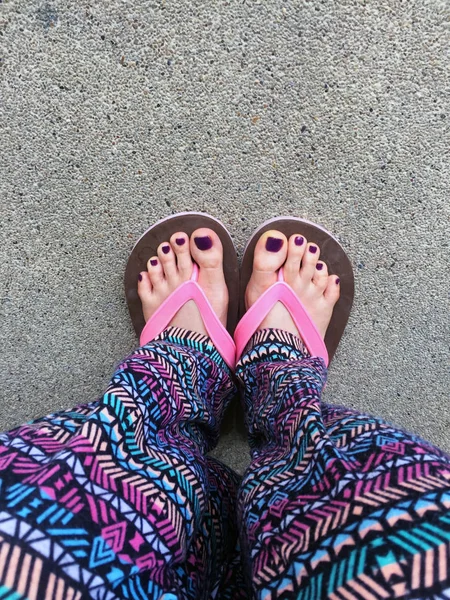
[{"xmin": 234, "ymin": 269, "xmax": 329, "ymax": 366}]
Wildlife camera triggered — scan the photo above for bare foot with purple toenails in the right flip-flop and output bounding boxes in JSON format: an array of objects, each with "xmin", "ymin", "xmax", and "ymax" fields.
[{"xmin": 245, "ymin": 230, "xmax": 340, "ymax": 339}]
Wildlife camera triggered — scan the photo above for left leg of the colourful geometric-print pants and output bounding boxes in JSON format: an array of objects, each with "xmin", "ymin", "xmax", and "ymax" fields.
[{"xmin": 0, "ymin": 328, "xmax": 246, "ymax": 600}]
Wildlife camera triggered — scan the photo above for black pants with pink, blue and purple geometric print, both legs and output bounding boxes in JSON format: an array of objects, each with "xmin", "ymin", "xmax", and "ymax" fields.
[{"xmin": 0, "ymin": 327, "xmax": 450, "ymax": 600}]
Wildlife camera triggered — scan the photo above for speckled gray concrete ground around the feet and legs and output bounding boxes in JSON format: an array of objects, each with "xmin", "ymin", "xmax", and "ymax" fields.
[{"xmin": 0, "ymin": 0, "xmax": 450, "ymax": 469}]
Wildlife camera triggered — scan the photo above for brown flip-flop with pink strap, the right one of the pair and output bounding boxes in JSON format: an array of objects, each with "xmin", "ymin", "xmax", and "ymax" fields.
[{"xmin": 234, "ymin": 217, "xmax": 354, "ymax": 366}]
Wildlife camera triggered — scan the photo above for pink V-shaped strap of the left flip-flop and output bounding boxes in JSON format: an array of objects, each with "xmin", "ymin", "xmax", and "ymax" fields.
[{"xmin": 140, "ymin": 265, "xmax": 236, "ymax": 369}]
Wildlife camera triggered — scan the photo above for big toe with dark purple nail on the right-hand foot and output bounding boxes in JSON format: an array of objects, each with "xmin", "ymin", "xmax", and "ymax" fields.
[{"xmin": 246, "ymin": 230, "xmax": 288, "ymax": 307}]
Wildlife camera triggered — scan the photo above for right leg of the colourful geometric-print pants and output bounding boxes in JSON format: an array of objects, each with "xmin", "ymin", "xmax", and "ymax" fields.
[{"xmin": 237, "ymin": 330, "xmax": 450, "ymax": 600}]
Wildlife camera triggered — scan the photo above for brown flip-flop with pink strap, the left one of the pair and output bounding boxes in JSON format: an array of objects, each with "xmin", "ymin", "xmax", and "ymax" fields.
[{"xmin": 125, "ymin": 212, "xmax": 239, "ymax": 369}]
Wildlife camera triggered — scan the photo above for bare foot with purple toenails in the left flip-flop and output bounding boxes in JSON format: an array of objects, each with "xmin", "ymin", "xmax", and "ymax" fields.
[{"xmin": 138, "ymin": 228, "xmax": 228, "ymax": 335}]
